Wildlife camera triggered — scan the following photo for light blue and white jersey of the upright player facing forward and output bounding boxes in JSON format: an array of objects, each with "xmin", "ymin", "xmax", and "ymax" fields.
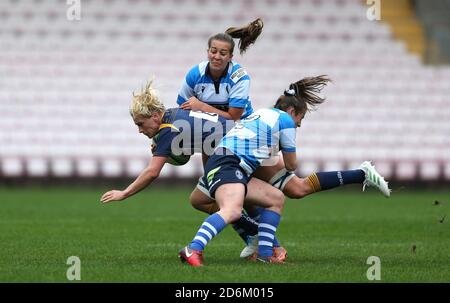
[{"xmin": 177, "ymin": 61, "xmax": 253, "ymax": 119}]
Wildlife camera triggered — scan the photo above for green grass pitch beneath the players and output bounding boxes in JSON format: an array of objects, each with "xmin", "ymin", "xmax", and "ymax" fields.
[{"xmin": 0, "ymin": 187, "xmax": 450, "ymax": 283}]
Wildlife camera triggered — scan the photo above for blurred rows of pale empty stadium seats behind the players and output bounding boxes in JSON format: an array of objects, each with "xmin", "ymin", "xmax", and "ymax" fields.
[{"xmin": 0, "ymin": 0, "xmax": 450, "ymax": 184}]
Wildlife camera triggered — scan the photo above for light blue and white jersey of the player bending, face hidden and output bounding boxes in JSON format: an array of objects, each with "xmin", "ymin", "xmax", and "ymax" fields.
[{"xmin": 218, "ymin": 108, "xmax": 296, "ymax": 174}]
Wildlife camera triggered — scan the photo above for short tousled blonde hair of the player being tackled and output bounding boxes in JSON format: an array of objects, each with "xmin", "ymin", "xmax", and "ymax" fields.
[{"xmin": 130, "ymin": 80, "xmax": 166, "ymax": 118}]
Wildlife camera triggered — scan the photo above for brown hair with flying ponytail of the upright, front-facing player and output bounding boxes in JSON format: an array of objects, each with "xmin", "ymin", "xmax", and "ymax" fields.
[{"xmin": 208, "ymin": 18, "xmax": 264, "ymax": 55}]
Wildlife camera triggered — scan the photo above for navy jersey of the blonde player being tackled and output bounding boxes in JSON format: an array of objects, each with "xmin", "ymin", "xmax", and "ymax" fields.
[{"xmin": 153, "ymin": 108, "xmax": 234, "ymax": 157}]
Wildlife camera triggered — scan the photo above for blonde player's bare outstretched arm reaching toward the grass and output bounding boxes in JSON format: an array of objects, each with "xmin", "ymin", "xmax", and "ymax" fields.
[{"xmin": 100, "ymin": 157, "xmax": 167, "ymax": 203}]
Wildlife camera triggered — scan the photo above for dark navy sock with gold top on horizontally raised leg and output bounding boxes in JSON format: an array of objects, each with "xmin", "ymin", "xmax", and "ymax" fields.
[{"xmin": 307, "ymin": 169, "xmax": 365, "ymax": 192}]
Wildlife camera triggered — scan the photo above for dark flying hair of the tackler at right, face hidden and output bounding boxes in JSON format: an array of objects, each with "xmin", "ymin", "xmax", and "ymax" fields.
[{"xmin": 274, "ymin": 75, "xmax": 331, "ymax": 114}]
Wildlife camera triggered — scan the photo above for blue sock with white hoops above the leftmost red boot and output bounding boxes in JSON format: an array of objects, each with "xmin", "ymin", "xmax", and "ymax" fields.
[{"xmin": 189, "ymin": 213, "xmax": 227, "ymax": 251}]
